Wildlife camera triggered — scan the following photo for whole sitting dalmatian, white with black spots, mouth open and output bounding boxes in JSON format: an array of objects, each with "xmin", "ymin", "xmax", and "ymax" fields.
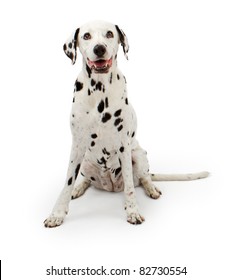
[{"xmin": 44, "ymin": 21, "xmax": 208, "ymax": 227}]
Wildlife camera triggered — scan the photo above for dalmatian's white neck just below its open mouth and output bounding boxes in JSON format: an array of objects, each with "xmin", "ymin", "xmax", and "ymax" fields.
[{"xmin": 83, "ymin": 60, "xmax": 117, "ymax": 83}]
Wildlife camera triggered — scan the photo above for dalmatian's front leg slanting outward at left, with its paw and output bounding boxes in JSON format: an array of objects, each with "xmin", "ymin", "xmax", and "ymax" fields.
[{"xmin": 44, "ymin": 142, "xmax": 84, "ymax": 227}]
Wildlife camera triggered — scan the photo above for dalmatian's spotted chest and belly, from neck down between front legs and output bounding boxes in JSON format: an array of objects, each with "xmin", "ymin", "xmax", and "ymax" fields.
[{"xmin": 71, "ymin": 73, "xmax": 135, "ymax": 191}]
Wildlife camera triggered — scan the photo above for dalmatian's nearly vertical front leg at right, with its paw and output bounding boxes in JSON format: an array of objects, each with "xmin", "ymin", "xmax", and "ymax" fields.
[{"xmin": 120, "ymin": 149, "xmax": 144, "ymax": 224}]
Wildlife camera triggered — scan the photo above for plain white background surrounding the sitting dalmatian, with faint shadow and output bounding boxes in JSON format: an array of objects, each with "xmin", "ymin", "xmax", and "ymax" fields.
[{"xmin": 0, "ymin": 0, "xmax": 232, "ymax": 280}]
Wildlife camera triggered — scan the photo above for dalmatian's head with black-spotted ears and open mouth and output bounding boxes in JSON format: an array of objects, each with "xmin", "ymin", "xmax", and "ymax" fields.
[{"xmin": 64, "ymin": 21, "xmax": 129, "ymax": 73}]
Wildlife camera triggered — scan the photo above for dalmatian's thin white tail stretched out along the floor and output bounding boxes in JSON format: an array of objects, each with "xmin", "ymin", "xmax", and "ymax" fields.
[{"xmin": 150, "ymin": 171, "xmax": 209, "ymax": 181}]
